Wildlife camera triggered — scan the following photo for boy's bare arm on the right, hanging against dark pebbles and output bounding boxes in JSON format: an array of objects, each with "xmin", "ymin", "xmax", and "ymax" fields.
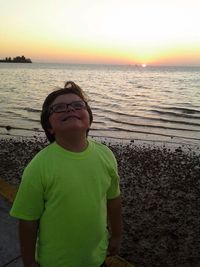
[{"xmin": 107, "ymin": 197, "xmax": 122, "ymax": 256}]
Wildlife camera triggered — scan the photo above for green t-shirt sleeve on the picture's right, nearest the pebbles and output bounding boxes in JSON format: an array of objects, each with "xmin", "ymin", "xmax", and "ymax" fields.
[{"xmin": 107, "ymin": 152, "xmax": 120, "ymax": 199}]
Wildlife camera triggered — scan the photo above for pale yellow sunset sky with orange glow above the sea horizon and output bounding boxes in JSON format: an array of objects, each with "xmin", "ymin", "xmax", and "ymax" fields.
[{"xmin": 0, "ymin": 0, "xmax": 200, "ymax": 66}]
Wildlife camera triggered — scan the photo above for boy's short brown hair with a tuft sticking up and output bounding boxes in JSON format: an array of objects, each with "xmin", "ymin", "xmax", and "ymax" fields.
[{"xmin": 40, "ymin": 81, "xmax": 93, "ymax": 143}]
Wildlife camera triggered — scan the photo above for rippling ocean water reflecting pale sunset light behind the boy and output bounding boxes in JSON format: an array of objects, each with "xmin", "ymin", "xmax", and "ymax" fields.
[{"xmin": 0, "ymin": 63, "xmax": 200, "ymax": 145}]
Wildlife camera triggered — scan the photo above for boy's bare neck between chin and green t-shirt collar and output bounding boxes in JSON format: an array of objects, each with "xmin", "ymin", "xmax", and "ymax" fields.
[{"xmin": 56, "ymin": 136, "xmax": 88, "ymax": 152}]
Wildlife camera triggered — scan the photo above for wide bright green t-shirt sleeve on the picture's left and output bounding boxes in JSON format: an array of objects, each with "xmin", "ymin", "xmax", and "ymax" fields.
[{"xmin": 10, "ymin": 161, "xmax": 44, "ymax": 220}]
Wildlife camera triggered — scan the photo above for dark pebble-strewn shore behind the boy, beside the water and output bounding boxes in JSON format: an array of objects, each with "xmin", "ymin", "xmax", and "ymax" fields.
[{"xmin": 0, "ymin": 138, "xmax": 200, "ymax": 267}]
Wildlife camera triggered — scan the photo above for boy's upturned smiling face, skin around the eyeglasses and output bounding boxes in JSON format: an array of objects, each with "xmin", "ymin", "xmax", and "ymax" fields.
[{"xmin": 49, "ymin": 94, "xmax": 90, "ymax": 138}]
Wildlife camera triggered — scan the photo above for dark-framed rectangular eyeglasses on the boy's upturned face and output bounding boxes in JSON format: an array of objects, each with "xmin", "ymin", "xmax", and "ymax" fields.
[{"xmin": 49, "ymin": 101, "xmax": 86, "ymax": 115}]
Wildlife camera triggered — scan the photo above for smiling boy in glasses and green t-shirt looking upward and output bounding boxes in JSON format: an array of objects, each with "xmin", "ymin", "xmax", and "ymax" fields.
[{"xmin": 10, "ymin": 82, "xmax": 121, "ymax": 267}]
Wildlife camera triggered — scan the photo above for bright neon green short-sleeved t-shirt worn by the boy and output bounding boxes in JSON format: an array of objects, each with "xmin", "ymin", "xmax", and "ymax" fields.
[{"xmin": 10, "ymin": 140, "xmax": 120, "ymax": 267}]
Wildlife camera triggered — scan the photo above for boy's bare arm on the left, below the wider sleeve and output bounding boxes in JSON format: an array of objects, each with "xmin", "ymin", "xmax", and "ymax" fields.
[{"xmin": 19, "ymin": 220, "xmax": 39, "ymax": 267}]
